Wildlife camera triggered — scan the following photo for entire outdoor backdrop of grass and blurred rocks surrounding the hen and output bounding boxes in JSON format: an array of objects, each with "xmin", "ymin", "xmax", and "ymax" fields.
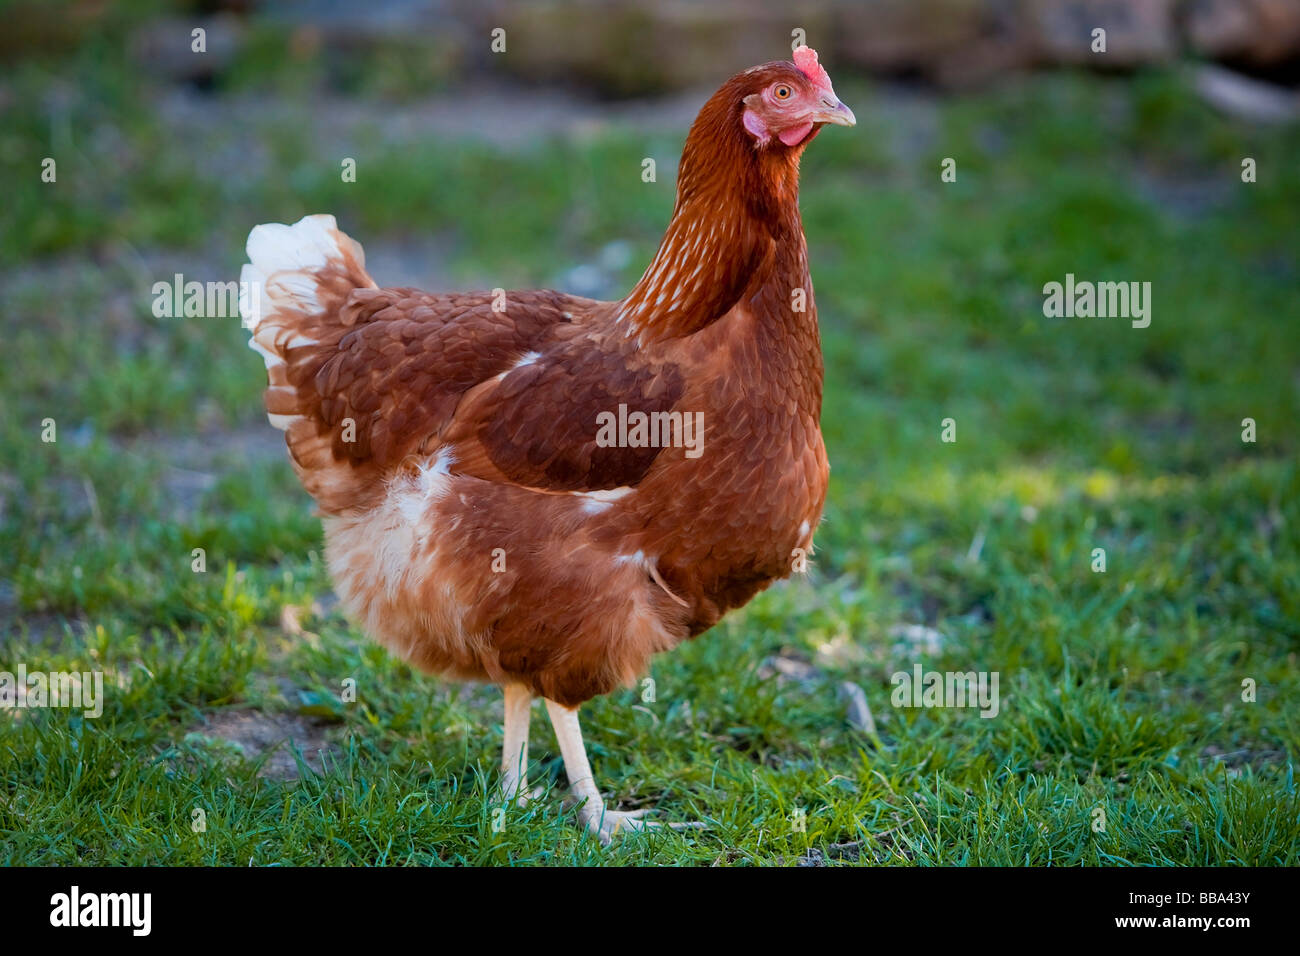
[{"xmin": 0, "ymin": 0, "xmax": 1300, "ymax": 864}]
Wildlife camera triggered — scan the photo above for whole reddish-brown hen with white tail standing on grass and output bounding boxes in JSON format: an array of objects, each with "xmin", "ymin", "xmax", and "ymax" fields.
[{"xmin": 241, "ymin": 47, "xmax": 854, "ymax": 842}]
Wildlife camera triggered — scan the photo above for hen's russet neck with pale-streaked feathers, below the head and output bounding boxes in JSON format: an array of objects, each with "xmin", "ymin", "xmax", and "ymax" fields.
[{"xmin": 618, "ymin": 107, "xmax": 816, "ymax": 343}]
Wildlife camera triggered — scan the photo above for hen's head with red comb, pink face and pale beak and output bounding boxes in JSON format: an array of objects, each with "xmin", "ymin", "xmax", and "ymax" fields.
[{"xmin": 733, "ymin": 47, "xmax": 857, "ymax": 148}]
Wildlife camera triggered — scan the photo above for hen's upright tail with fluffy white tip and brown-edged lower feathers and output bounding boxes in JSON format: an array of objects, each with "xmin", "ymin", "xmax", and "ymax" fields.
[{"xmin": 239, "ymin": 216, "xmax": 376, "ymax": 511}]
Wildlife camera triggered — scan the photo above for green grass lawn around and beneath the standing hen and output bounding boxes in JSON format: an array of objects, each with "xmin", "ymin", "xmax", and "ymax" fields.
[{"xmin": 0, "ymin": 31, "xmax": 1300, "ymax": 865}]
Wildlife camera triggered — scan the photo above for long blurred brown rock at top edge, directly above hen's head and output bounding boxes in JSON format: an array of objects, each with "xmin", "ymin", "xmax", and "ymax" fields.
[{"xmin": 469, "ymin": 0, "xmax": 1024, "ymax": 96}]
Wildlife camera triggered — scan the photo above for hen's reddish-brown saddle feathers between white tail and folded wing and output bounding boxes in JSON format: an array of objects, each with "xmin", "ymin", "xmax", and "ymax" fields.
[{"xmin": 282, "ymin": 289, "xmax": 595, "ymax": 514}]
